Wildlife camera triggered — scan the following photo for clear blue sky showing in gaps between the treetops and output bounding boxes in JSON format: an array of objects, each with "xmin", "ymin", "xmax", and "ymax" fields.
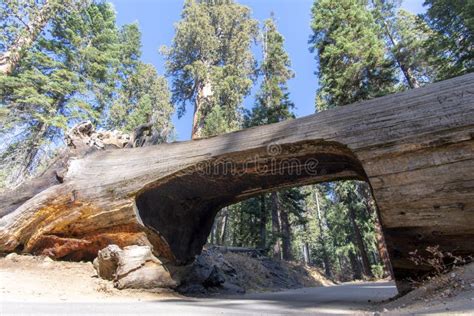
[{"xmin": 111, "ymin": 0, "xmax": 424, "ymax": 140}]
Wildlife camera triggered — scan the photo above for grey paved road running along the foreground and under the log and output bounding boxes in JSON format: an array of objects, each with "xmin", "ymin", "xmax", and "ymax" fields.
[{"xmin": 0, "ymin": 282, "xmax": 397, "ymax": 316}]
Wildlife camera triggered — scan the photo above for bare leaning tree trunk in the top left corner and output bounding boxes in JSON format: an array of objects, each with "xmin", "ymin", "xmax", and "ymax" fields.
[{"xmin": 0, "ymin": 0, "xmax": 57, "ymax": 75}]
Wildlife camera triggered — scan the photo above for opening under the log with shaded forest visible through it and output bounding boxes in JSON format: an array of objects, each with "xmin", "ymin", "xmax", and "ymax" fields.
[{"xmin": 206, "ymin": 180, "xmax": 392, "ymax": 284}]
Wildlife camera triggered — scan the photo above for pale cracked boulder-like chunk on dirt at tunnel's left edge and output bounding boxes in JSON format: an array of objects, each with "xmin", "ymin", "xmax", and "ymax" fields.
[{"xmin": 94, "ymin": 245, "xmax": 177, "ymax": 289}]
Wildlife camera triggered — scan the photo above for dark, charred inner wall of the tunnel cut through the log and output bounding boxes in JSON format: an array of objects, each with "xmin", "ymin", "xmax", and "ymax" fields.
[{"xmin": 136, "ymin": 140, "xmax": 388, "ymax": 265}]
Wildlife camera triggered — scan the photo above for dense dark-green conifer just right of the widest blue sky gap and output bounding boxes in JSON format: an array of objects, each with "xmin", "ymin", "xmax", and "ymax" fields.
[{"xmin": 310, "ymin": 0, "xmax": 394, "ymax": 110}]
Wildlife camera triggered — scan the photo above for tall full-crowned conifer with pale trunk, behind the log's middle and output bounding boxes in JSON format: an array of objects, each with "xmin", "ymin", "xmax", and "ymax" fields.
[{"xmin": 163, "ymin": 0, "xmax": 257, "ymax": 138}]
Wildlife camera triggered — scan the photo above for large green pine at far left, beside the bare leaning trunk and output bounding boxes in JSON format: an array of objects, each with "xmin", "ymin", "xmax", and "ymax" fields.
[{"xmin": 0, "ymin": 2, "xmax": 121, "ymax": 186}]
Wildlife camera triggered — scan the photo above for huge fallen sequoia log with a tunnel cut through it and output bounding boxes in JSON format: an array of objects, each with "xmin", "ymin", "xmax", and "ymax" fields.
[{"xmin": 0, "ymin": 74, "xmax": 474, "ymax": 291}]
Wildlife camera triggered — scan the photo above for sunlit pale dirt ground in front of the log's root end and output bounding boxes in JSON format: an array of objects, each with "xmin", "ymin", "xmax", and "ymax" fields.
[{"xmin": 0, "ymin": 254, "xmax": 180, "ymax": 302}]
